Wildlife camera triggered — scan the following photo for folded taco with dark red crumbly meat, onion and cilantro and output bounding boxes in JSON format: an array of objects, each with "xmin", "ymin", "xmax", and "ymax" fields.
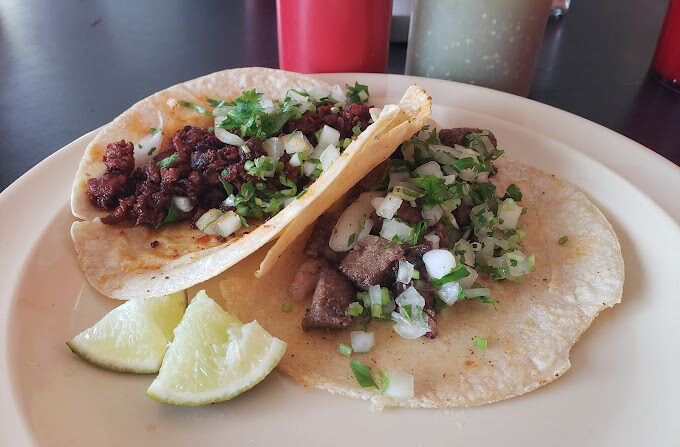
[{"xmin": 71, "ymin": 68, "xmax": 430, "ymax": 299}]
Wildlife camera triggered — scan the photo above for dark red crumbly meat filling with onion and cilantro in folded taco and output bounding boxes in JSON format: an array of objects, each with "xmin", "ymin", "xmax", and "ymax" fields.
[{"xmin": 85, "ymin": 83, "xmax": 381, "ymax": 239}]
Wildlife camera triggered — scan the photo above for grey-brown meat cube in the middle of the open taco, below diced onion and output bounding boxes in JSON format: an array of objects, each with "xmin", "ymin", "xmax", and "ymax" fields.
[{"xmin": 340, "ymin": 235, "xmax": 404, "ymax": 291}]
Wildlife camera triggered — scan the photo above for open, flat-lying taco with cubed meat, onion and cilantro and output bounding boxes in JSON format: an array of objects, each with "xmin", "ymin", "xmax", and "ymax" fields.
[{"xmin": 220, "ymin": 126, "xmax": 624, "ymax": 408}]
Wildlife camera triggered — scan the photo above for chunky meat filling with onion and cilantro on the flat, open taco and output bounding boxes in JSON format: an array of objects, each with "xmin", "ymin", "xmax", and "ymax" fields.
[{"xmin": 289, "ymin": 126, "xmax": 535, "ymax": 339}]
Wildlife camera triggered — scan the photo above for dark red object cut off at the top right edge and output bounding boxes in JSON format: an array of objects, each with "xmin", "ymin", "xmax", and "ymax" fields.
[{"xmin": 652, "ymin": 0, "xmax": 680, "ymax": 91}]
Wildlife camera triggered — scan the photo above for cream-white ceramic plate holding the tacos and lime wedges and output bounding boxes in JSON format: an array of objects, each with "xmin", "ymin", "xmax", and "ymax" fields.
[{"xmin": 0, "ymin": 74, "xmax": 680, "ymax": 447}]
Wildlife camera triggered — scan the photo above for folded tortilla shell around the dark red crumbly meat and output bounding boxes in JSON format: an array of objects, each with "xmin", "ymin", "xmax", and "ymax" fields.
[{"xmin": 71, "ymin": 68, "xmax": 430, "ymax": 299}]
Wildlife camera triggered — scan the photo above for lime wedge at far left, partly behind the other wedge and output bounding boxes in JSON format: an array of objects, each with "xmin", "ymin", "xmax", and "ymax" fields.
[{"xmin": 66, "ymin": 291, "xmax": 187, "ymax": 373}]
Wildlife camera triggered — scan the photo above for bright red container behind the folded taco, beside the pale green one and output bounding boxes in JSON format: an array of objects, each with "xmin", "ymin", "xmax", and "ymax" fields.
[{"xmin": 276, "ymin": 0, "xmax": 392, "ymax": 73}]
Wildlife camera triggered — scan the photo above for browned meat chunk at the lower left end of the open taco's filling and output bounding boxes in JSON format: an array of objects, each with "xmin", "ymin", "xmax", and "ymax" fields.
[{"xmin": 302, "ymin": 268, "xmax": 356, "ymax": 331}]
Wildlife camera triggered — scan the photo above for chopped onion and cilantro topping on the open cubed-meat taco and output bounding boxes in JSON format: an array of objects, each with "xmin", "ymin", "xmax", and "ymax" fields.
[{"xmin": 329, "ymin": 126, "xmax": 532, "ymax": 342}]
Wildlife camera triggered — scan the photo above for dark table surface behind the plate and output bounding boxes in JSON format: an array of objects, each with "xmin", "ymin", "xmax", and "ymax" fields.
[{"xmin": 0, "ymin": 0, "xmax": 680, "ymax": 191}]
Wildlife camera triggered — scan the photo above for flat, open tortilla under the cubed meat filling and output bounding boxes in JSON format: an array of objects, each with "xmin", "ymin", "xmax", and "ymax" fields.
[{"xmin": 220, "ymin": 160, "xmax": 624, "ymax": 408}]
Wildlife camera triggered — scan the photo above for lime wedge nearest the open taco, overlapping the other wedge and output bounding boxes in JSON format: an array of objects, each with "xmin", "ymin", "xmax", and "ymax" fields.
[{"xmin": 146, "ymin": 290, "xmax": 286, "ymax": 406}]
